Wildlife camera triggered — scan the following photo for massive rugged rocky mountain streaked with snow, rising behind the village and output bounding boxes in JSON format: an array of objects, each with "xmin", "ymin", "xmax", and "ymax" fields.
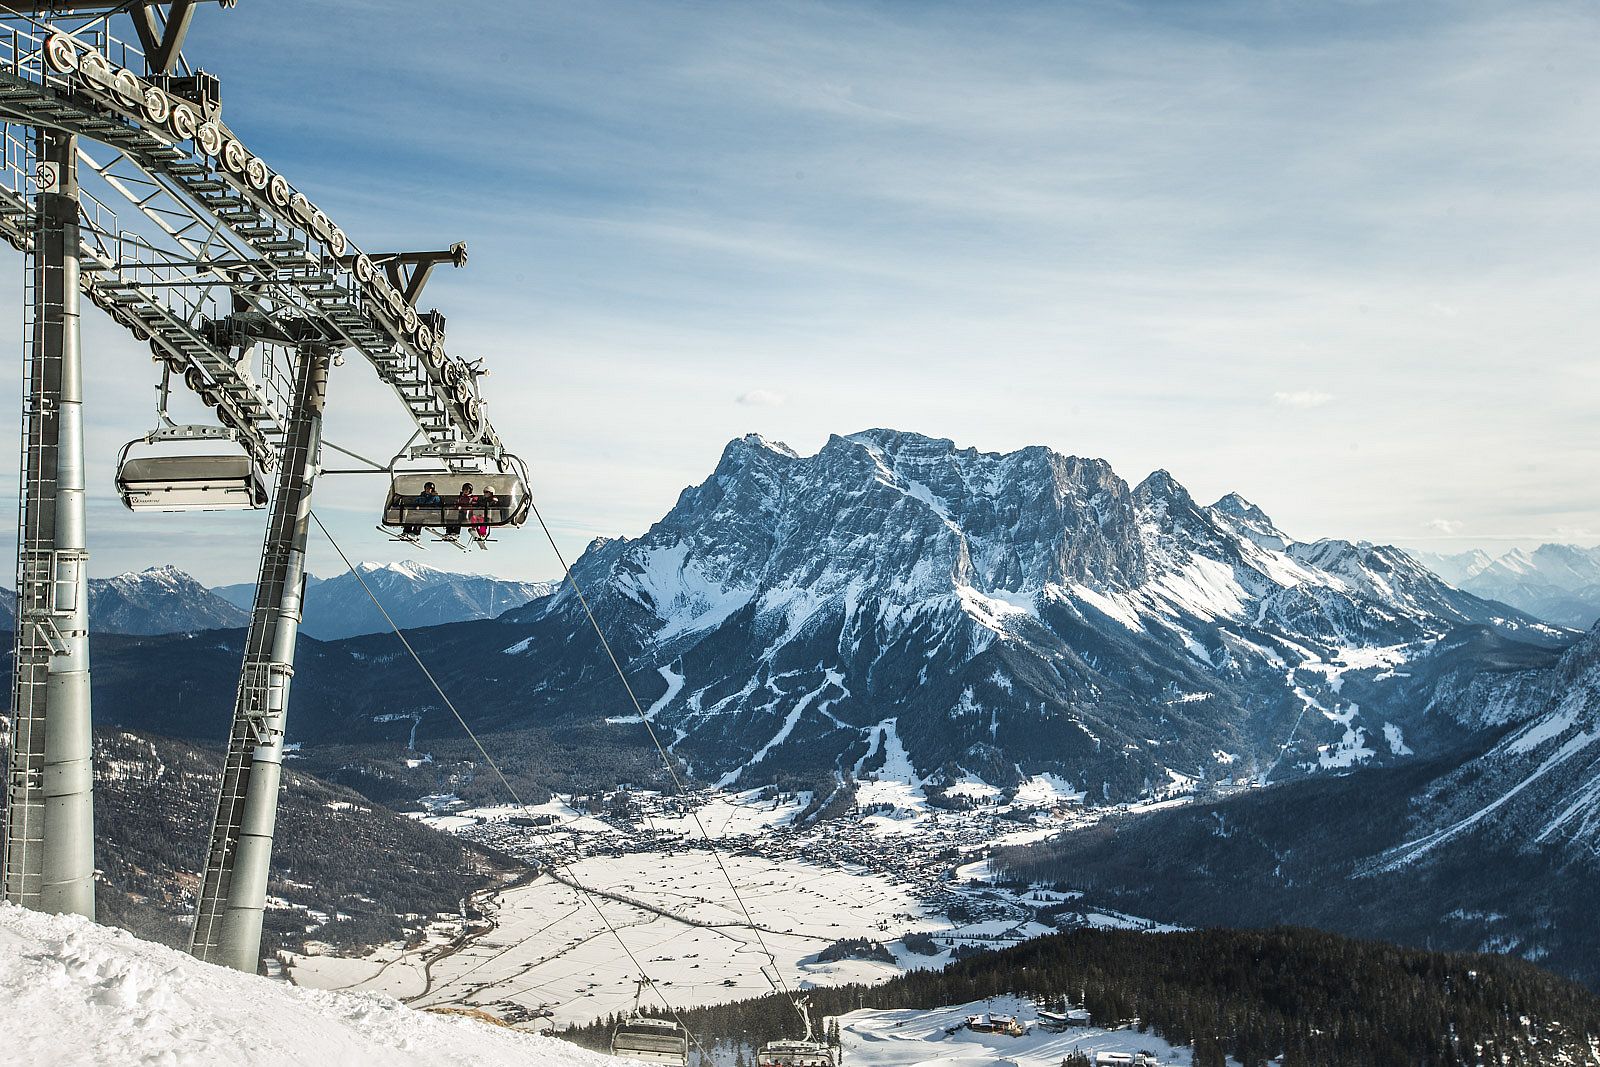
[{"xmin": 504, "ymin": 430, "xmax": 1548, "ymax": 800}]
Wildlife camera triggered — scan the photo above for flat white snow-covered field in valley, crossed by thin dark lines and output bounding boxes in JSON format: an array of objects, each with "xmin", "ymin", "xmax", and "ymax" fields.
[{"xmin": 291, "ymin": 851, "xmax": 972, "ymax": 1022}]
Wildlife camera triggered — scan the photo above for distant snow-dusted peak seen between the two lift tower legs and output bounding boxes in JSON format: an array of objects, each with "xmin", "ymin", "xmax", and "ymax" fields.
[{"xmin": 0, "ymin": 566, "xmax": 250, "ymax": 633}]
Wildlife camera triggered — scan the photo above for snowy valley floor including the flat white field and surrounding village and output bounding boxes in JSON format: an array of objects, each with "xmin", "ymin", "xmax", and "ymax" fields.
[{"xmin": 286, "ymin": 793, "xmax": 1184, "ymax": 1025}]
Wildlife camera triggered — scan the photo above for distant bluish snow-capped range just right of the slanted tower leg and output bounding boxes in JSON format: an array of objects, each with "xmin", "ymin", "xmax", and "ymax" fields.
[{"xmin": 213, "ymin": 560, "xmax": 552, "ymax": 641}]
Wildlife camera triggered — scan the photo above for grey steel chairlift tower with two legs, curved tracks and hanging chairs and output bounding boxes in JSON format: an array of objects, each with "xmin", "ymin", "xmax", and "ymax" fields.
[{"xmin": 0, "ymin": 0, "xmax": 530, "ymax": 971}]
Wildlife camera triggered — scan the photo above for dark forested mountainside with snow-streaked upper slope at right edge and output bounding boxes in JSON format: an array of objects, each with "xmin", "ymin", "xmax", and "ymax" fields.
[{"xmin": 998, "ymin": 617, "xmax": 1600, "ymax": 987}]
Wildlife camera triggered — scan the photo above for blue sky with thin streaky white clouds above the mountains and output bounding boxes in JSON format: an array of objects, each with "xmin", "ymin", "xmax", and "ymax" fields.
[{"xmin": 0, "ymin": 0, "xmax": 1600, "ymax": 584}]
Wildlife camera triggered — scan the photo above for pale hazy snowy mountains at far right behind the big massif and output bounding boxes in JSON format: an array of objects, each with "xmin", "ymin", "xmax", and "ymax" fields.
[{"xmin": 1416, "ymin": 544, "xmax": 1600, "ymax": 629}]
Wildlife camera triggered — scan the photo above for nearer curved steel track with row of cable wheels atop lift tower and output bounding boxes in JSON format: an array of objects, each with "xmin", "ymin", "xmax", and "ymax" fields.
[{"xmin": 0, "ymin": 13, "xmax": 501, "ymax": 467}]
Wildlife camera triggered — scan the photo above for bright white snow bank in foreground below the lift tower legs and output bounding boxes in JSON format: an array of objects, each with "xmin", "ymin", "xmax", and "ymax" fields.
[{"xmin": 0, "ymin": 904, "xmax": 618, "ymax": 1067}]
